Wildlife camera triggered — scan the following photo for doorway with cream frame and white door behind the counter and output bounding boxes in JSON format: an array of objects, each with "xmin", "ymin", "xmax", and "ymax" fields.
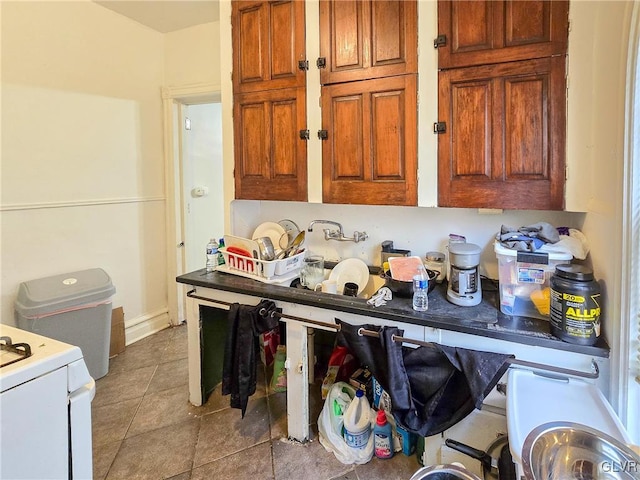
[{"xmin": 162, "ymin": 84, "xmax": 226, "ymax": 325}]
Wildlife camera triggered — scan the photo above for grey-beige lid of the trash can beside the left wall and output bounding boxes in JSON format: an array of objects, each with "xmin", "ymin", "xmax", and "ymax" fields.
[{"xmin": 15, "ymin": 268, "xmax": 116, "ymax": 317}]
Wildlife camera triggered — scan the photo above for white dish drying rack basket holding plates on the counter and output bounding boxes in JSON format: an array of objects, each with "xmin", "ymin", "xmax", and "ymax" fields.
[{"xmin": 218, "ymin": 247, "xmax": 305, "ymax": 284}]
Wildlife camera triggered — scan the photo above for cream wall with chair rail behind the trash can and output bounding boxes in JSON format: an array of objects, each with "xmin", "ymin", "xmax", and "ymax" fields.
[{"xmin": 0, "ymin": 1, "xmax": 168, "ymax": 337}]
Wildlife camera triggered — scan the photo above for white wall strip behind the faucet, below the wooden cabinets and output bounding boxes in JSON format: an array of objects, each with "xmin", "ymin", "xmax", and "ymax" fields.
[{"xmin": 232, "ymin": 200, "xmax": 584, "ymax": 278}]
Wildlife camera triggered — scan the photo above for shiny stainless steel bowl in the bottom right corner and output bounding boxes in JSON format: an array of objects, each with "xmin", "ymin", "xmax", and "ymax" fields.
[{"xmin": 522, "ymin": 422, "xmax": 640, "ymax": 480}]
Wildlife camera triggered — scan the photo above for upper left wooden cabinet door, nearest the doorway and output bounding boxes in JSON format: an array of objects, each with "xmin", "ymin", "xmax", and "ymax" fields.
[{"xmin": 231, "ymin": 0, "xmax": 306, "ymax": 93}]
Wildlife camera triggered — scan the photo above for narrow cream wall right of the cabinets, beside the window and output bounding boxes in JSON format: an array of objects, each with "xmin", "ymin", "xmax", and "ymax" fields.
[{"xmin": 567, "ymin": 1, "xmax": 640, "ymax": 416}]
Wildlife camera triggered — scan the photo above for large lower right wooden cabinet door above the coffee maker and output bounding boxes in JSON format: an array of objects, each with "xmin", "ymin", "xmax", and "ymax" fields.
[{"xmin": 438, "ymin": 56, "xmax": 566, "ymax": 210}]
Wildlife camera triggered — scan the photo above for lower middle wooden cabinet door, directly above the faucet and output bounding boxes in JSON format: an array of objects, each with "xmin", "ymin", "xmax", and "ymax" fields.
[{"xmin": 322, "ymin": 75, "xmax": 417, "ymax": 205}]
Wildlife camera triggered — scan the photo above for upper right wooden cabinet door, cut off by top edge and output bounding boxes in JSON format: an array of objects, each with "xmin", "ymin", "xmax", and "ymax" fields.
[{"xmin": 438, "ymin": 0, "xmax": 569, "ymax": 68}]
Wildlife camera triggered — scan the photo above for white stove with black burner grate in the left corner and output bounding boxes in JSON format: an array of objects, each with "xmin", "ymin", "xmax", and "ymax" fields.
[{"xmin": 0, "ymin": 324, "xmax": 95, "ymax": 480}]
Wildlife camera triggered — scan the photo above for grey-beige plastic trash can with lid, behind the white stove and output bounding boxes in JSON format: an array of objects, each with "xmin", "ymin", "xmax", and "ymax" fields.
[{"xmin": 15, "ymin": 268, "xmax": 116, "ymax": 379}]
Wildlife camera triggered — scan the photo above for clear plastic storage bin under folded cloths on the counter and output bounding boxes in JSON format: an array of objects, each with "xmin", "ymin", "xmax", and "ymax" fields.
[{"xmin": 494, "ymin": 242, "xmax": 573, "ymax": 320}]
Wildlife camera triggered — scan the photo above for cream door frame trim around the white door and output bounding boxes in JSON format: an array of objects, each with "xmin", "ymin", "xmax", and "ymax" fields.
[{"xmin": 162, "ymin": 83, "xmax": 222, "ymax": 326}]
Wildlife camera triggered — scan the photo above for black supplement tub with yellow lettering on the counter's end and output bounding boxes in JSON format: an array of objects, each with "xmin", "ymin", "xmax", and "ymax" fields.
[{"xmin": 550, "ymin": 265, "xmax": 601, "ymax": 345}]
